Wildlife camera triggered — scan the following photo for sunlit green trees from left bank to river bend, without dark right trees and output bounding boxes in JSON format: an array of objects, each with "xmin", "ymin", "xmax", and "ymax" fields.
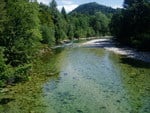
[{"xmin": 0, "ymin": 0, "xmax": 115, "ymax": 87}]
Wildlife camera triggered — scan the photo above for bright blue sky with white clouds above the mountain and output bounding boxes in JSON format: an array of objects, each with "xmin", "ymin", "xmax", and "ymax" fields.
[{"xmin": 37, "ymin": 0, "xmax": 124, "ymax": 12}]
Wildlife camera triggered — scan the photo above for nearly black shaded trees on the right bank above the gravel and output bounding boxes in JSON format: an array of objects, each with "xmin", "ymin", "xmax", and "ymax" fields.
[{"xmin": 110, "ymin": 0, "xmax": 150, "ymax": 50}]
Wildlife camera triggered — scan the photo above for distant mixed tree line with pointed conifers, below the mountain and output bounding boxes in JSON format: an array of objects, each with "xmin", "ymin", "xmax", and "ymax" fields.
[{"xmin": 39, "ymin": 0, "xmax": 111, "ymax": 44}]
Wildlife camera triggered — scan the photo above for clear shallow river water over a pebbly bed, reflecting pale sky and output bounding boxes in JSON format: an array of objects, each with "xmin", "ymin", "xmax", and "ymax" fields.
[{"xmin": 0, "ymin": 48, "xmax": 150, "ymax": 113}]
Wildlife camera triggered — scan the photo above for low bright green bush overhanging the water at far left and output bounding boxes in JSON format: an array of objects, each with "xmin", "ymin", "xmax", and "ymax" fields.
[{"xmin": 0, "ymin": 48, "xmax": 32, "ymax": 87}]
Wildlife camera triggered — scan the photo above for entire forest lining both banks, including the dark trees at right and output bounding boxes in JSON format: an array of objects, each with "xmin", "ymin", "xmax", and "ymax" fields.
[{"xmin": 0, "ymin": 0, "xmax": 150, "ymax": 87}]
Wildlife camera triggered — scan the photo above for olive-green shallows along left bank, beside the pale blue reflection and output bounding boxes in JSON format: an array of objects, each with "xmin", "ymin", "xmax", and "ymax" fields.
[{"xmin": 0, "ymin": 49, "xmax": 57, "ymax": 113}]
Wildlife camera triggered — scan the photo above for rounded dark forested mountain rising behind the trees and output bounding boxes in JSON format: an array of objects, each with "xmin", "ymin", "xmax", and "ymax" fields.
[{"xmin": 70, "ymin": 2, "xmax": 117, "ymax": 15}]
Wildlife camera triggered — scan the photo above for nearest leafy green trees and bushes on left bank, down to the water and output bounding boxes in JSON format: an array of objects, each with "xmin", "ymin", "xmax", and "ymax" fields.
[{"xmin": 0, "ymin": 0, "xmax": 41, "ymax": 86}]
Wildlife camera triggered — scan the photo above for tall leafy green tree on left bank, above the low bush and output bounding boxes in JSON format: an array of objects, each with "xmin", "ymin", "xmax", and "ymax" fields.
[{"xmin": 1, "ymin": 0, "xmax": 41, "ymax": 66}]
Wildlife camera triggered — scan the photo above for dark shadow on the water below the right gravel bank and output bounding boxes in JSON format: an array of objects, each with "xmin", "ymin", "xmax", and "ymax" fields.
[{"xmin": 120, "ymin": 57, "xmax": 150, "ymax": 69}]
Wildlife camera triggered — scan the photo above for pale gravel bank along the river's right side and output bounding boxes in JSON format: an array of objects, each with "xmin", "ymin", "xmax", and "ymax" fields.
[{"xmin": 81, "ymin": 39, "xmax": 150, "ymax": 63}]
